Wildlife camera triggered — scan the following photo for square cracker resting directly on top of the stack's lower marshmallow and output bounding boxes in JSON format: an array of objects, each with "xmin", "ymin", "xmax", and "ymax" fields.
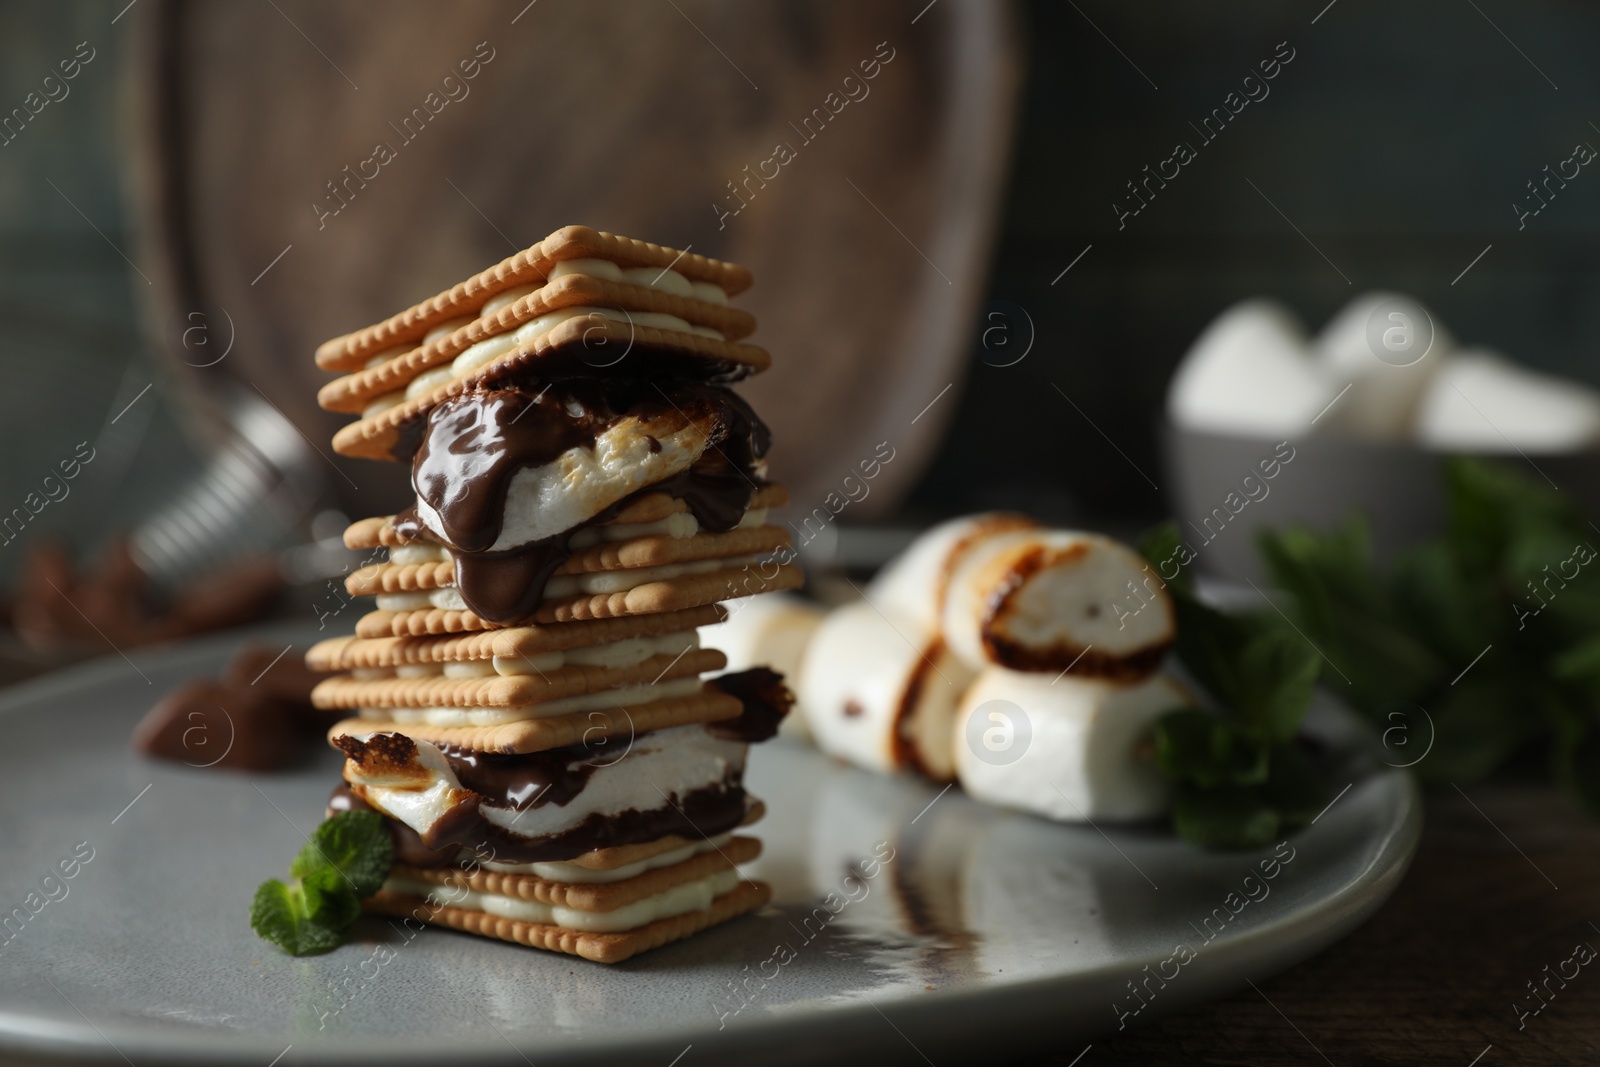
[{"xmin": 328, "ymin": 689, "xmax": 744, "ymax": 755}]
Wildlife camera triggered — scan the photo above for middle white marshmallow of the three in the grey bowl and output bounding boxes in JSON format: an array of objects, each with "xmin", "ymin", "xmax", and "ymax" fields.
[{"xmin": 1314, "ymin": 291, "xmax": 1456, "ymax": 440}]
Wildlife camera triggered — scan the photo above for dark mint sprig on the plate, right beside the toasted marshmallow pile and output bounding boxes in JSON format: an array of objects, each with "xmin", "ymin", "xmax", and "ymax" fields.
[{"xmin": 1141, "ymin": 523, "xmax": 1326, "ymax": 848}]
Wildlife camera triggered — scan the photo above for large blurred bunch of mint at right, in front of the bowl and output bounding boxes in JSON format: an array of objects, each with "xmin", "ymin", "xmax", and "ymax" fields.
[{"xmin": 1261, "ymin": 458, "xmax": 1600, "ymax": 814}]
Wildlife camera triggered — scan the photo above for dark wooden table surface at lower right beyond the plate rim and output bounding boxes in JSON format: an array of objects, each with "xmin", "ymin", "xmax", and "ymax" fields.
[{"xmin": 1035, "ymin": 784, "xmax": 1600, "ymax": 1067}]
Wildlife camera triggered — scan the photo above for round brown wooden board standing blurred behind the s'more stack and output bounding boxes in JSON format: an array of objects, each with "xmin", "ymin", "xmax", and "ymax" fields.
[{"xmin": 130, "ymin": 0, "xmax": 1019, "ymax": 518}]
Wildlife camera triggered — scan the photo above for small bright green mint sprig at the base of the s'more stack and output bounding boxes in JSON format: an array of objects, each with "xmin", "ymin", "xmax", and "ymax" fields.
[{"xmin": 250, "ymin": 811, "xmax": 394, "ymax": 957}]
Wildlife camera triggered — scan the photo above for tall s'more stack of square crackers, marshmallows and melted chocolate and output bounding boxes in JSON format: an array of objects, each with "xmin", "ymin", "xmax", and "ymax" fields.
[{"xmin": 307, "ymin": 227, "xmax": 802, "ymax": 963}]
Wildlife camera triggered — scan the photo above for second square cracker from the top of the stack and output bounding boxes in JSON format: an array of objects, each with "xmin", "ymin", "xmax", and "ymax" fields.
[{"xmin": 317, "ymin": 274, "xmax": 755, "ymax": 413}]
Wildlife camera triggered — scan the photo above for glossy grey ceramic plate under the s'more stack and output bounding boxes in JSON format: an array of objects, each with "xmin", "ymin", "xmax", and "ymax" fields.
[{"xmin": 0, "ymin": 635, "xmax": 1421, "ymax": 1067}]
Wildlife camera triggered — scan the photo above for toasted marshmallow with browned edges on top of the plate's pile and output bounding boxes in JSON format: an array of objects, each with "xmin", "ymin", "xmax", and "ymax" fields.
[{"xmin": 942, "ymin": 530, "xmax": 1174, "ymax": 681}]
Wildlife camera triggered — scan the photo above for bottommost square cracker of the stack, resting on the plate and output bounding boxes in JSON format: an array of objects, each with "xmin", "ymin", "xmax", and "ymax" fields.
[{"xmin": 363, "ymin": 881, "xmax": 773, "ymax": 963}]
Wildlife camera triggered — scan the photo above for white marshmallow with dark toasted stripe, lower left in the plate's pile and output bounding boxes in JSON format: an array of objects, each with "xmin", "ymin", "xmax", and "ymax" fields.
[{"xmin": 800, "ymin": 601, "xmax": 973, "ymax": 781}]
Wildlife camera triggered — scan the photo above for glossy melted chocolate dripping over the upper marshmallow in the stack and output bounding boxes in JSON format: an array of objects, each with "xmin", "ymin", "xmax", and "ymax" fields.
[{"xmin": 394, "ymin": 378, "xmax": 771, "ymax": 624}]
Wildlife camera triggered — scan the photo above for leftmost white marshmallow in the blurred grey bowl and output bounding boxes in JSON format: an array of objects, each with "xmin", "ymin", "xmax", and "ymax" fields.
[{"xmin": 1166, "ymin": 299, "xmax": 1344, "ymax": 437}]
